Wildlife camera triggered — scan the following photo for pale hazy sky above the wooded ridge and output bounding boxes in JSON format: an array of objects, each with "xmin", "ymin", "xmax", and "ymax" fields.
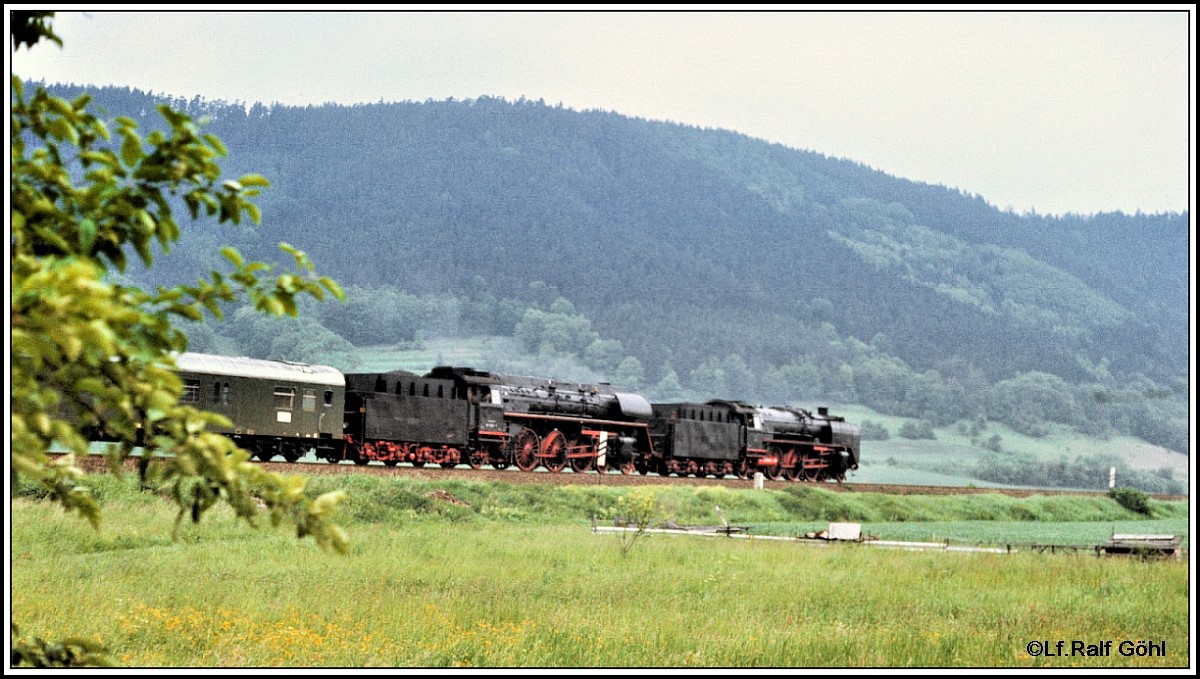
[{"xmin": 6, "ymin": 5, "xmax": 1195, "ymax": 214}]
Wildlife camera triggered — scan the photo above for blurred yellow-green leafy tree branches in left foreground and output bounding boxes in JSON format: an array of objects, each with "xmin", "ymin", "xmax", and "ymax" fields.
[{"xmin": 10, "ymin": 11, "xmax": 347, "ymax": 665}]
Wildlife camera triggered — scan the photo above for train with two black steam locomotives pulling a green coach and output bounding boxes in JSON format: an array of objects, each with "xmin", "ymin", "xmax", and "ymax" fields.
[{"xmin": 176, "ymin": 354, "xmax": 859, "ymax": 481}]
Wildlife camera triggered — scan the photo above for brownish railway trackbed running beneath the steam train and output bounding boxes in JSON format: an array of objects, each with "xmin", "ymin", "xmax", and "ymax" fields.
[{"xmin": 56, "ymin": 456, "xmax": 1188, "ymax": 500}]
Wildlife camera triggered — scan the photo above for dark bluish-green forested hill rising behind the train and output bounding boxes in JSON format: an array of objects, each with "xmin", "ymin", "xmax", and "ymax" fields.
[{"xmin": 35, "ymin": 88, "xmax": 1188, "ymax": 458}]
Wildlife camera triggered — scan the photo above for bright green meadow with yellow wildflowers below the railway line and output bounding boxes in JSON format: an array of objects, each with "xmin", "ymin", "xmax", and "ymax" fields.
[{"xmin": 11, "ymin": 476, "xmax": 1190, "ymax": 668}]
